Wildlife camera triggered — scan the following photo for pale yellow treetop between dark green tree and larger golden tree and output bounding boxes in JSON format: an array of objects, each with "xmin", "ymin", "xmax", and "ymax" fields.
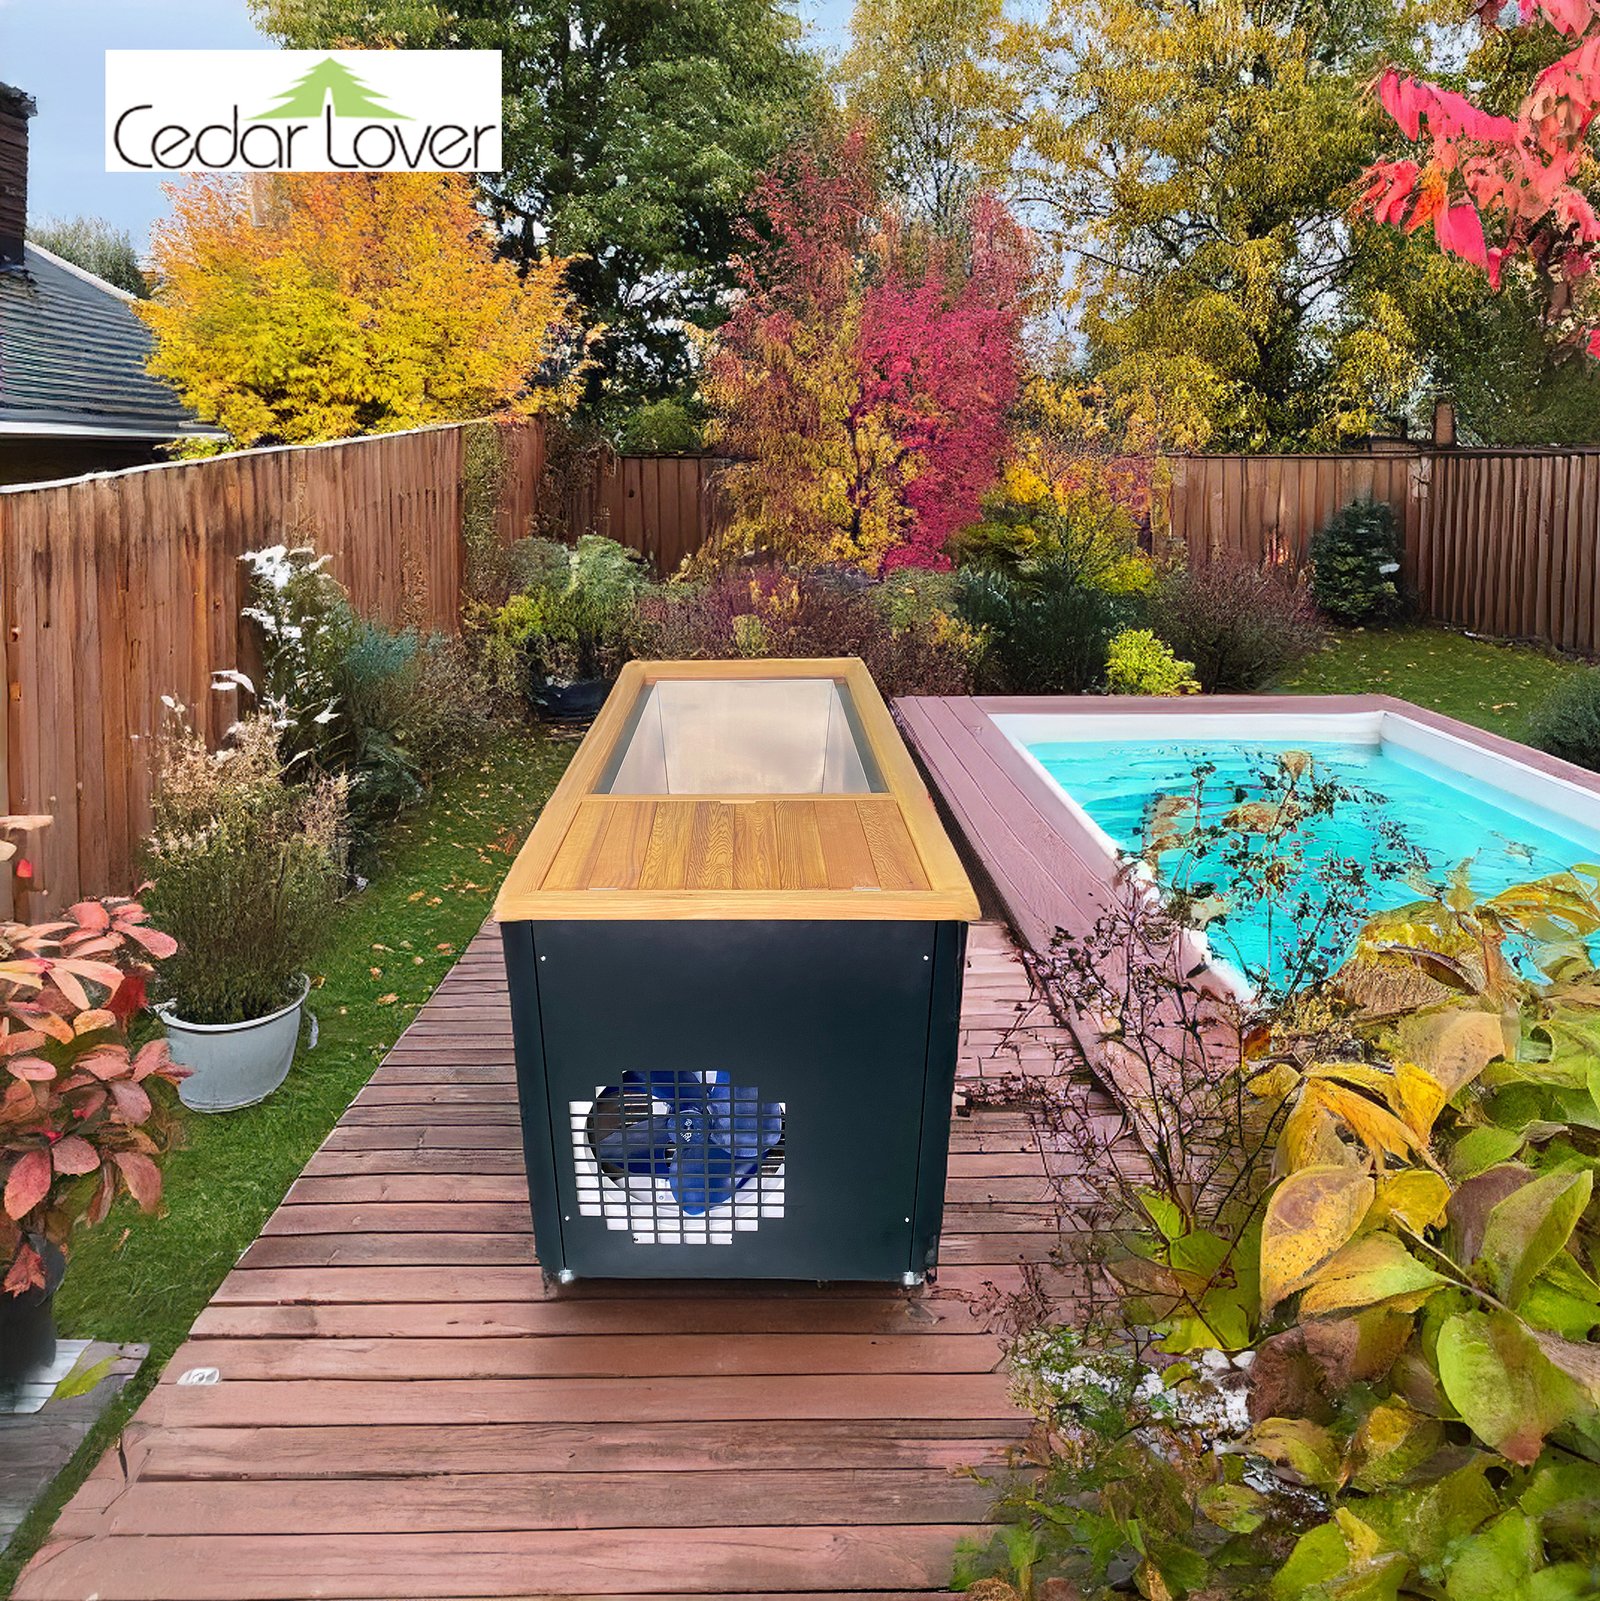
[{"xmin": 839, "ymin": 0, "xmax": 1004, "ymax": 232}]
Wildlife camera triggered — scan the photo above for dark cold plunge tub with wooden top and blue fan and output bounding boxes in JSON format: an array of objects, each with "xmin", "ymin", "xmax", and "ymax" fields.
[{"xmin": 495, "ymin": 660, "xmax": 979, "ymax": 1282}]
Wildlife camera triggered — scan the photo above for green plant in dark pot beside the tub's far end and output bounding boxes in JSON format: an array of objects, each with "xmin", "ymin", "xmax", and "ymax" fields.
[{"xmin": 495, "ymin": 533, "xmax": 647, "ymax": 719}]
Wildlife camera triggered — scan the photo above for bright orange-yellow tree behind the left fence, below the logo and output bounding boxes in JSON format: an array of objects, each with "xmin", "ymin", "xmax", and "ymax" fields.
[{"xmin": 138, "ymin": 173, "xmax": 581, "ymax": 445}]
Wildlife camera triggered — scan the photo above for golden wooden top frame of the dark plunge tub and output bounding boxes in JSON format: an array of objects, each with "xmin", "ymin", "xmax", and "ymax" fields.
[{"xmin": 495, "ymin": 656, "xmax": 979, "ymax": 922}]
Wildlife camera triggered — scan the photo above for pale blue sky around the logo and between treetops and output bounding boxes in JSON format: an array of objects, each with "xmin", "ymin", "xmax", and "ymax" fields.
[{"xmin": 0, "ymin": 0, "xmax": 850, "ymax": 251}]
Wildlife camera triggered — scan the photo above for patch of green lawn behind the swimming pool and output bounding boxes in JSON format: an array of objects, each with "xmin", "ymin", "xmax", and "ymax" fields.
[{"xmin": 1278, "ymin": 628, "xmax": 1582, "ymax": 740}]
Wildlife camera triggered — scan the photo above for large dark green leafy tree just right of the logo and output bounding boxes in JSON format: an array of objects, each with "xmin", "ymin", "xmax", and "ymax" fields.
[{"xmin": 250, "ymin": 0, "xmax": 818, "ymax": 402}]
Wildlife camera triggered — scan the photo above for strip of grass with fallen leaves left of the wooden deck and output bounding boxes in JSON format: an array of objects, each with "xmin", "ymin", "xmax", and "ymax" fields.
[{"xmin": 0, "ymin": 733, "xmax": 577, "ymax": 1595}]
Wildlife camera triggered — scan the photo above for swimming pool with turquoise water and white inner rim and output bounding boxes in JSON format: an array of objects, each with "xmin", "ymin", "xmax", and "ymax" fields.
[{"xmin": 993, "ymin": 703, "xmax": 1600, "ymax": 980}]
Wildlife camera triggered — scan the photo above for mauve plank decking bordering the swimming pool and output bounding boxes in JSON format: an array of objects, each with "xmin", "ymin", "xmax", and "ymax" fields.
[{"xmin": 894, "ymin": 695, "xmax": 1600, "ymax": 954}]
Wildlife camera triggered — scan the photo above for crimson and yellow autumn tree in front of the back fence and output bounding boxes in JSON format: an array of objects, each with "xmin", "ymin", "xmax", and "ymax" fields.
[{"xmin": 705, "ymin": 131, "xmax": 1033, "ymax": 570}]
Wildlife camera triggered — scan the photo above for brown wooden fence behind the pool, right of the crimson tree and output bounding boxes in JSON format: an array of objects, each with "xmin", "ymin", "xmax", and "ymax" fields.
[{"xmin": 1158, "ymin": 448, "xmax": 1600, "ymax": 656}]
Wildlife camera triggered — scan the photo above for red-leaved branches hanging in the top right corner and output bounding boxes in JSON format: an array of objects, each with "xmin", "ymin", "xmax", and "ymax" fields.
[{"xmin": 1360, "ymin": 0, "xmax": 1600, "ymax": 355}]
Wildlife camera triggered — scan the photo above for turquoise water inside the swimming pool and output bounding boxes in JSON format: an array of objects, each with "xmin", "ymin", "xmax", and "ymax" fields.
[{"xmin": 1027, "ymin": 740, "xmax": 1600, "ymax": 972}]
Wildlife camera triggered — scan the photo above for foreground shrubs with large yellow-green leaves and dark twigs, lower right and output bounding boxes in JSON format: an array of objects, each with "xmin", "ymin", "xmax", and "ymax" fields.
[{"xmin": 959, "ymin": 781, "xmax": 1600, "ymax": 1601}]
